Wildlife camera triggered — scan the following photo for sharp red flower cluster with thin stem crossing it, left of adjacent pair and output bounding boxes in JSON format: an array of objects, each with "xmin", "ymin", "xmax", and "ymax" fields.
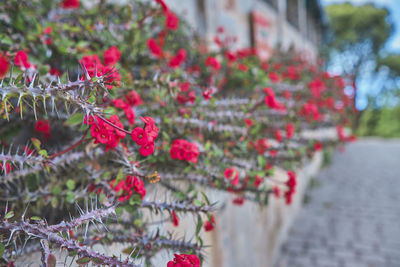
[{"xmin": 84, "ymin": 115, "xmax": 126, "ymax": 151}]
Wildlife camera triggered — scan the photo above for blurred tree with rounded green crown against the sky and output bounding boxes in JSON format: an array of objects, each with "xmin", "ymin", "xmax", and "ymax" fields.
[{"xmin": 326, "ymin": 3, "xmax": 393, "ymax": 130}]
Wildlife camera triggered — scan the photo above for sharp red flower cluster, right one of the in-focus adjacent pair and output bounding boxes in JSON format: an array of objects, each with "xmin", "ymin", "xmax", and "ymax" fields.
[{"xmin": 131, "ymin": 117, "xmax": 158, "ymax": 157}]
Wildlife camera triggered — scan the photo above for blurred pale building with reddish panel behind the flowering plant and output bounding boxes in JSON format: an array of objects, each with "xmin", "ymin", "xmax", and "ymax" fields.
[{"xmin": 166, "ymin": 0, "xmax": 324, "ymax": 59}]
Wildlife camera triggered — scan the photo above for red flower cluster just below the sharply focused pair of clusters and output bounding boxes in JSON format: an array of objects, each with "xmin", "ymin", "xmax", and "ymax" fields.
[{"xmin": 110, "ymin": 175, "xmax": 146, "ymax": 202}]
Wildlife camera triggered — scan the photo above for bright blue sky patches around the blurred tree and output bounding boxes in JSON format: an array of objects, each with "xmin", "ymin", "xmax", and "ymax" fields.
[{"xmin": 321, "ymin": 0, "xmax": 400, "ymax": 109}]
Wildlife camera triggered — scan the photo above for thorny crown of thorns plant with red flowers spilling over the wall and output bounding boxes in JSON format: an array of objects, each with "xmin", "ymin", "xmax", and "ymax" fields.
[{"xmin": 0, "ymin": 0, "xmax": 354, "ymax": 267}]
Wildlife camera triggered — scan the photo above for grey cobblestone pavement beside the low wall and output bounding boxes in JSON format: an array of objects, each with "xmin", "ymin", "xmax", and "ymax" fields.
[{"xmin": 275, "ymin": 139, "xmax": 400, "ymax": 267}]
